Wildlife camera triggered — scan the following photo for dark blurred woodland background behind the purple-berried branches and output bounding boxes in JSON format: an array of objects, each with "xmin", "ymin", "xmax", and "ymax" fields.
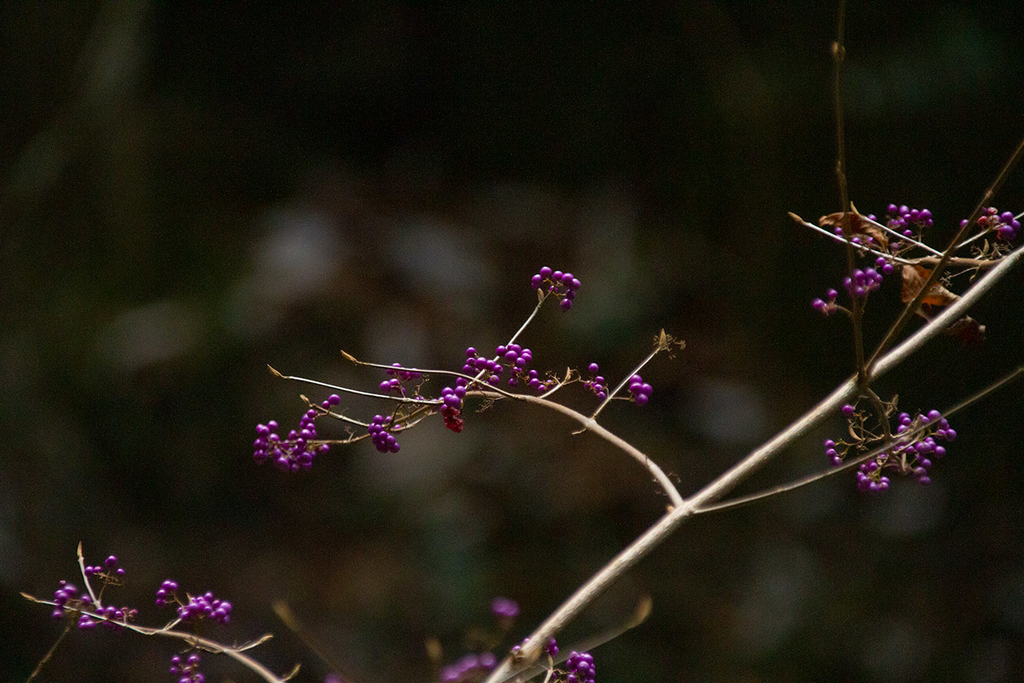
[{"xmin": 6, "ymin": 1, "xmax": 1024, "ymax": 683}]
